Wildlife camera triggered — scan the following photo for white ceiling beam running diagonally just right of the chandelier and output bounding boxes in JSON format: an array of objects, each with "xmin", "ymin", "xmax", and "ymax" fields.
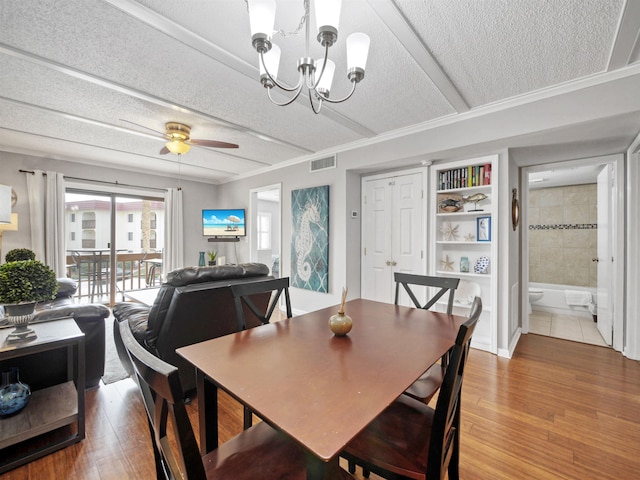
[{"xmin": 367, "ymin": 0, "xmax": 469, "ymax": 113}]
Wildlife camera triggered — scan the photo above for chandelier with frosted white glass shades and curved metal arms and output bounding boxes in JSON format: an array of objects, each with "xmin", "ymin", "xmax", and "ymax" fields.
[{"xmin": 247, "ymin": 0, "xmax": 369, "ymax": 114}]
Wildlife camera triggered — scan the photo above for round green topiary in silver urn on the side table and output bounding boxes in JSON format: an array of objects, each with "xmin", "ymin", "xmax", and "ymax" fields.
[{"xmin": 0, "ymin": 260, "xmax": 58, "ymax": 342}]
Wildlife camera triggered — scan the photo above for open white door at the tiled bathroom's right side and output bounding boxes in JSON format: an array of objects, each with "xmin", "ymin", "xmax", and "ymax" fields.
[{"xmin": 597, "ymin": 164, "xmax": 613, "ymax": 345}]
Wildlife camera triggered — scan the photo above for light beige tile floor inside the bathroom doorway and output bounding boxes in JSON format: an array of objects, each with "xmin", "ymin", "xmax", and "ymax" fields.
[{"xmin": 529, "ymin": 310, "xmax": 607, "ymax": 347}]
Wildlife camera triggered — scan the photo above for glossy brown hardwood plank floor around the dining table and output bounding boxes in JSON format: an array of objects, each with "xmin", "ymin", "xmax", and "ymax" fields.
[{"xmin": 0, "ymin": 334, "xmax": 640, "ymax": 480}]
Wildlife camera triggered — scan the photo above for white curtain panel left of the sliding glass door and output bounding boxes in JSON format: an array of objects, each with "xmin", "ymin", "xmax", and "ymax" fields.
[{"xmin": 27, "ymin": 170, "xmax": 67, "ymax": 277}]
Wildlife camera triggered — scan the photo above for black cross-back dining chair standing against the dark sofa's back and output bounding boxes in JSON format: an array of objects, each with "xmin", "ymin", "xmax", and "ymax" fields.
[{"xmin": 231, "ymin": 277, "xmax": 293, "ymax": 429}]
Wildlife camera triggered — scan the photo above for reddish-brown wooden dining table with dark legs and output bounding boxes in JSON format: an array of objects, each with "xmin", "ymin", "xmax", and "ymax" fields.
[{"xmin": 177, "ymin": 299, "xmax": 466, "ymax": 480}]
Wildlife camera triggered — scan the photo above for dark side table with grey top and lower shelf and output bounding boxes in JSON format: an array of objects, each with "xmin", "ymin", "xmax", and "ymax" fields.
[{"xmin": 0, "ymin": 318, "xmax": 85, "ymax": 473}]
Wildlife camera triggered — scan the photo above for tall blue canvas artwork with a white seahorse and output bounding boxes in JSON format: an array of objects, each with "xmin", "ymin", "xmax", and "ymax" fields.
[{"xmin": 291, "ymin": 185, "xmax": 329, "ymax": 293}]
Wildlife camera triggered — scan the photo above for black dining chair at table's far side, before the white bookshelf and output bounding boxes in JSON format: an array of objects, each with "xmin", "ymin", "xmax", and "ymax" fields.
[{"xmin": 394, "ymin": 272, "xmax": 460, "ymax": 404}]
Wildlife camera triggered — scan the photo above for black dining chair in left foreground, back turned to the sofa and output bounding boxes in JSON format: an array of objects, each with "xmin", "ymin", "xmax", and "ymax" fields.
[{"xmin": 120, "ymin": 322, "xmax": 353, "ymax": 480}]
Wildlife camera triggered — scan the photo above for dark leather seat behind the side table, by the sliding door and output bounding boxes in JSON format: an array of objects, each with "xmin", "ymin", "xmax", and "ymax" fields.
[{"xmin": 0, "ymin": 278, "xmax": 109, "ymax": 389}]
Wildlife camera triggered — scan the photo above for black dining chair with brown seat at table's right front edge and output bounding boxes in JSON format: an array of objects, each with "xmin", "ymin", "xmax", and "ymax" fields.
[{"xmin": 340, "ymin": 297, "xmax": 482, "ymax": 480}]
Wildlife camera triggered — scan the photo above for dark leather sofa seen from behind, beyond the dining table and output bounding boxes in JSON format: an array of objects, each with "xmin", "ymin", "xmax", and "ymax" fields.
[{"xmin": 113, "ymin": 263, "xmax": 273, "ymax": 394}]
